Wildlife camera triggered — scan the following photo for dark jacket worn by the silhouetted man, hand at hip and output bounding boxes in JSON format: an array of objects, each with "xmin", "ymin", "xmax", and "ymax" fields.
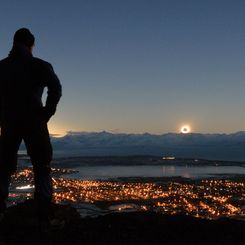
[{"xmin": 0, "ymin": 46, "xmax": 61, "ymax": 126}]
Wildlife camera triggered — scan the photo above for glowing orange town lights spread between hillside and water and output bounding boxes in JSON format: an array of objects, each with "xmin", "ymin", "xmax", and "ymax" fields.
[{"xmin": 11, "ymin": 169, "xmax": 245, "ymax": 219}]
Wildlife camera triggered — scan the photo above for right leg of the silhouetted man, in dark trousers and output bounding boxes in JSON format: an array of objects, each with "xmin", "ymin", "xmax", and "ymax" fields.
[{"xmin": 24, "ymin": 123, "xmax": 52, "ymax": 218}]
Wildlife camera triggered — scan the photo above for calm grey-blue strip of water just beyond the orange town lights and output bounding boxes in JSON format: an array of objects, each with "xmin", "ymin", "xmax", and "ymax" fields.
[{"xmin": 68, "ymin": 165, "xmax": 245, "ymax": 180}]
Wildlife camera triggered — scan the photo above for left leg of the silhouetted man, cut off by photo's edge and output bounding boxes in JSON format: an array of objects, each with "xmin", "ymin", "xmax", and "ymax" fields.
[{"xmin": 0, "ymin": 127, "xmax": 21, "ymax": 212}]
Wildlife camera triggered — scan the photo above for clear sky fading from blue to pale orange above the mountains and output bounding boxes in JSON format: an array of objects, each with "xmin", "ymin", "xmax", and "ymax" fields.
[{"xmin": 0, "ymin": 0, "xmax": 245, "ymax": 134}]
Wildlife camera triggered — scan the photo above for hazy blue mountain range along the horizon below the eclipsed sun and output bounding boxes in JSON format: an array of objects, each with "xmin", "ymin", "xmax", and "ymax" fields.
[{"xmin": 47, "ymin": 131, "xmax": 245, "ymax": 161}]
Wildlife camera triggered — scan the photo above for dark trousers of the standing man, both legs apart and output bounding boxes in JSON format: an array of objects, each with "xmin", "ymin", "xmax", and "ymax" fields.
[{"xmin": 0, "ymin": 122, "xmax": 52, "ymax": 215}]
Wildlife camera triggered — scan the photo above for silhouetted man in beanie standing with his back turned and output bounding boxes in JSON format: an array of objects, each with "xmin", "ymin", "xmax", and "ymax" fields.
[{"xmin": 0, "ymin": 28, "xmax": 61, "ymax": 223}]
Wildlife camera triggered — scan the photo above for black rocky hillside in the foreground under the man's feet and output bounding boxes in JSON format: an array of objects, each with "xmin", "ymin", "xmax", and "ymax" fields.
[{"xmin": 0, "ymin": 202, "xmax": 245, "ymax": 245}]
